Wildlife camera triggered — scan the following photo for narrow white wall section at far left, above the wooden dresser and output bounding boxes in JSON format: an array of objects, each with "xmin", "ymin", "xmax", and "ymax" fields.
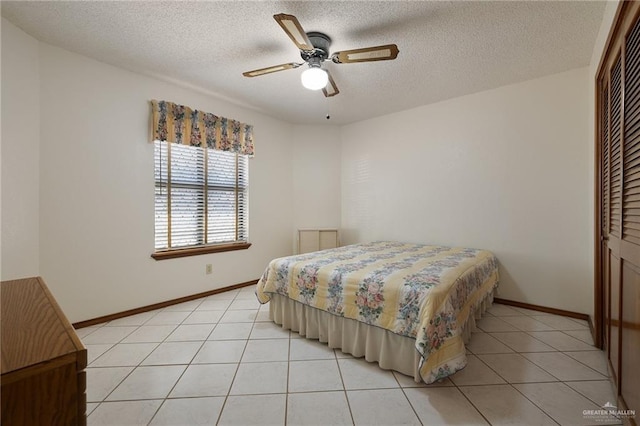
[{"xmin": 0, "ymin": 19, "xmax": 40, "ymax": 280}]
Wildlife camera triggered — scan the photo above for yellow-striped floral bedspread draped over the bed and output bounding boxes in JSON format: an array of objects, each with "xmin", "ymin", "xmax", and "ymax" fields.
[{"xmin": 256, "ymin": 242, "xmax": 498, "ymax": 383}]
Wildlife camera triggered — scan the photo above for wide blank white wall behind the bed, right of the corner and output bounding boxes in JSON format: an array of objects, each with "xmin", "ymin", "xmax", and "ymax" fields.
[{"xmin": 342, "ymin": 68, "xmax": 593, "ymax": 313}]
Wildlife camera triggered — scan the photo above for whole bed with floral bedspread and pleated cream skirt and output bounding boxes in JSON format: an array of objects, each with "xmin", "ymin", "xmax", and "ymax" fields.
[{"xmin": 256, "ymin": 241, "xmax": 498, "ymax": 383}]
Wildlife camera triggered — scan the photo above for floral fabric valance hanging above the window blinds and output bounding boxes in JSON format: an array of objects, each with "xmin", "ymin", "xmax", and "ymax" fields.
[{"xmin": 151, "ymin": 100, "xmax": 254, "ymax": 156}]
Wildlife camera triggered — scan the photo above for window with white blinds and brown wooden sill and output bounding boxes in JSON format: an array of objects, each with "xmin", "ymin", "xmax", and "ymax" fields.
[{"xmin": 152, "ymin": 141, "xmax": 249, "ymax": 259}]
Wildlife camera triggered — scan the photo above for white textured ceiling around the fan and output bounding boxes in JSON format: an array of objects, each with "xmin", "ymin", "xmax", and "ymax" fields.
[{"xmin": 1, "ymin": 1, "xmax": 604, "ymax": 124}]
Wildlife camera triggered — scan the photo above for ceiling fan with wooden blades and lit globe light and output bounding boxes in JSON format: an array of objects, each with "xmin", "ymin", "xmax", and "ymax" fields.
[{"xmin": 242, "ymin": 13, "xmax": 399, "ymax": 97}]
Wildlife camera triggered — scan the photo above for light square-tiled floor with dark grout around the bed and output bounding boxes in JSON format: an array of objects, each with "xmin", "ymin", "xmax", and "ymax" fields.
[{"xmin": 78, "ymin": 287, "xmax": 619, "ymax": 426}]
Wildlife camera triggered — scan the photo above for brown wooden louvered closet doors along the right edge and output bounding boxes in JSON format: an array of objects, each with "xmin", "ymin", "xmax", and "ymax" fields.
[{"xmin": 597, "ymin": 2, "xmax": 640, "ymax": 423}]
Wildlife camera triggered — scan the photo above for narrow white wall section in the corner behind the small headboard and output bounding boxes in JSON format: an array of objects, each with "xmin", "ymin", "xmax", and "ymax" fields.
[{"xmin": 292, "ymin": 125, "xmax": 341, "ymax": 251}]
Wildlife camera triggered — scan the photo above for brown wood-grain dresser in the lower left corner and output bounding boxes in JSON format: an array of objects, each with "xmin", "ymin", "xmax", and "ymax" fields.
[{"xmin": 0, "ymin": 277, "xmax": 87, "ymax": 426}]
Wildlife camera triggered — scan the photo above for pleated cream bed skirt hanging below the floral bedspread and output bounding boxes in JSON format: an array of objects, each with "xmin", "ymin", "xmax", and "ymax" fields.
[{"xmin": 269, "ymin": 292, "xmax": 493, "ymax": 383}]
